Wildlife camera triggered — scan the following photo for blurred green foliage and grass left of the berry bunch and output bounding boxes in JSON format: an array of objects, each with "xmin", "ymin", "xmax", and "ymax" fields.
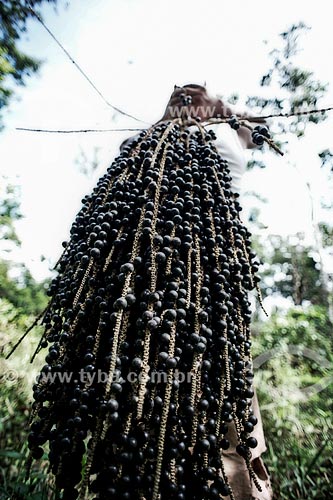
[{"xmin": 0, "ymin": 173, "xmax": 49, "ymax": 500}]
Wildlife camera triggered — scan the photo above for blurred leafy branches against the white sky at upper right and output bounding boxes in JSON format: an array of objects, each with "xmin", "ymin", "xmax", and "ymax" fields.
[{"xmin": 246, "ymin": 22, "xmax": 328, "ymax": 169}]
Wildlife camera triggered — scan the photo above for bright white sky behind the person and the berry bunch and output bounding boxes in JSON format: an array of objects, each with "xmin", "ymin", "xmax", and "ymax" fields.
[{"xmin": 0, "ymin": 0, "xmax": 333, "ymax": 279}]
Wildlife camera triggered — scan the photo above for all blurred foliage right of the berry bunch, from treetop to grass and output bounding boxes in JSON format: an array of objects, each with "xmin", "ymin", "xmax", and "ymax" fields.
[{"xmin": 239, "ymin": 23, "xmax": 333, "ymax": 500}]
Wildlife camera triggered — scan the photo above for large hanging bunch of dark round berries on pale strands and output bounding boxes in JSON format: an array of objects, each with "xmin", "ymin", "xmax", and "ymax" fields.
[{"xmin": 29, "ymin": 119, "xmax": 260, "ymax": 500}]
